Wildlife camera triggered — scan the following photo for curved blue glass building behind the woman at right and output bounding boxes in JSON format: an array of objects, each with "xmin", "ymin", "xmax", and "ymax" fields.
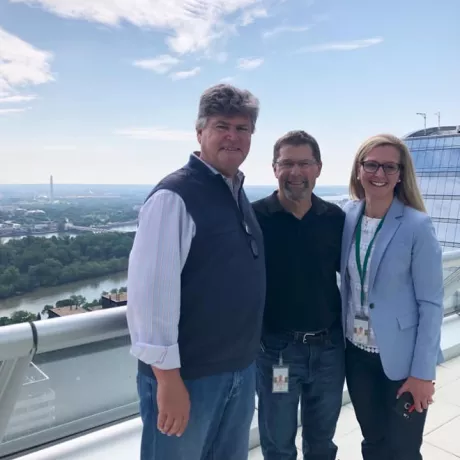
[{"xmin": 403, "ymin": 126, "xmax": 460, "ymax": 251}]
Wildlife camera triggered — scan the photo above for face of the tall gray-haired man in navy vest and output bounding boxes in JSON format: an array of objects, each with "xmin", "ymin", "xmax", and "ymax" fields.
[{"xmin": 197, "ymin": 115, "xmax": 252, "ymax": 177}]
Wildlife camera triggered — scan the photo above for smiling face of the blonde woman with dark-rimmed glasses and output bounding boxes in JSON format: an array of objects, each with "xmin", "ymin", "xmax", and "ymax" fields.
[{"xmin": 358, "ymin": 145, "xmax": 401, "ymax": 199}]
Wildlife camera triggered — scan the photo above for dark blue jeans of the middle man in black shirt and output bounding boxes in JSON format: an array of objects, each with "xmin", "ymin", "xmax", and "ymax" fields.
[{"xmin": 257, "ymin": 327, "xmax": 345, "ymax": 460}]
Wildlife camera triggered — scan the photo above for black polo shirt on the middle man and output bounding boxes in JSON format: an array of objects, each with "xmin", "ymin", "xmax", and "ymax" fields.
[{"xmin": 252, "ymin": 192, "xmax": 345, "ymax": 332}]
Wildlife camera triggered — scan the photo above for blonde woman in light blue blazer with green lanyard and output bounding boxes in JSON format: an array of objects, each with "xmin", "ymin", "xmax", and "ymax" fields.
[{"xmin": 341, "ymin": 135, "xmax": 443, "ymax": 460}]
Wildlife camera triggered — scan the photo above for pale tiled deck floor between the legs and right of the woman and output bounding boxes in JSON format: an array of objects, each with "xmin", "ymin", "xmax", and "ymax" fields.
[{"xmin": 249, "ymin": 357, "xmax": 460, "ymax": 460}]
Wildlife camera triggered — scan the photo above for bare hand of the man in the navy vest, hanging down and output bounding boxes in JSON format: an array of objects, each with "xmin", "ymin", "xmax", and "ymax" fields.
[{"xmin": 152, "ymin": 367, "xmax": 190, "ymax": 436}]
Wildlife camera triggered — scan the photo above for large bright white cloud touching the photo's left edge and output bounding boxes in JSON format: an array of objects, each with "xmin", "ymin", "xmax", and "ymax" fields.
[{"xmin": 0, "ymin": 27, "xmax": 54, "ymax": 92}]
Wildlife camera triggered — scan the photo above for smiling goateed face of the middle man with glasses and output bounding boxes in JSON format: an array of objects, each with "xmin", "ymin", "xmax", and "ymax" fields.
[{"xmin": 274, "ymin": 144, "xmax": 321, "ymax": 201}]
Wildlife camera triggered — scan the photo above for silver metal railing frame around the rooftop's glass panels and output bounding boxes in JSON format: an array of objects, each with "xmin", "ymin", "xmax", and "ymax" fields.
[{"xmin": 0, "ymin": 250, "xmax": 460, "ymax": 457}]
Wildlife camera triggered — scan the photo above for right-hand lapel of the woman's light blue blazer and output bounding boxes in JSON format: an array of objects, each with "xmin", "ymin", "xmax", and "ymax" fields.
[{"xmin": 368, "ymin": 198, "xmax": 404, "ymax": 292}]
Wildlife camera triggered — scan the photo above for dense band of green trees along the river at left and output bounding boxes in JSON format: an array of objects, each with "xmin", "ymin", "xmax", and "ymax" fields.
[{"xmin": 0, "ymin": 232, "xmax": 135, "ymax": 299}]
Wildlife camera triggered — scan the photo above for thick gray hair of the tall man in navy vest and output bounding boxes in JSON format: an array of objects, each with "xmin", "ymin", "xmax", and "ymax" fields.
[{"xmin": 196, "ymin": 84, "xmax": 259, "ymax": 132}]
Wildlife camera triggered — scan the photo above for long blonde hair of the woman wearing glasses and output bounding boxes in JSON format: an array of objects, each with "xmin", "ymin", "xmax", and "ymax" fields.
[{"xmin": 350, "ymin": 134, "xmax": 426, "ymax": 212}]
